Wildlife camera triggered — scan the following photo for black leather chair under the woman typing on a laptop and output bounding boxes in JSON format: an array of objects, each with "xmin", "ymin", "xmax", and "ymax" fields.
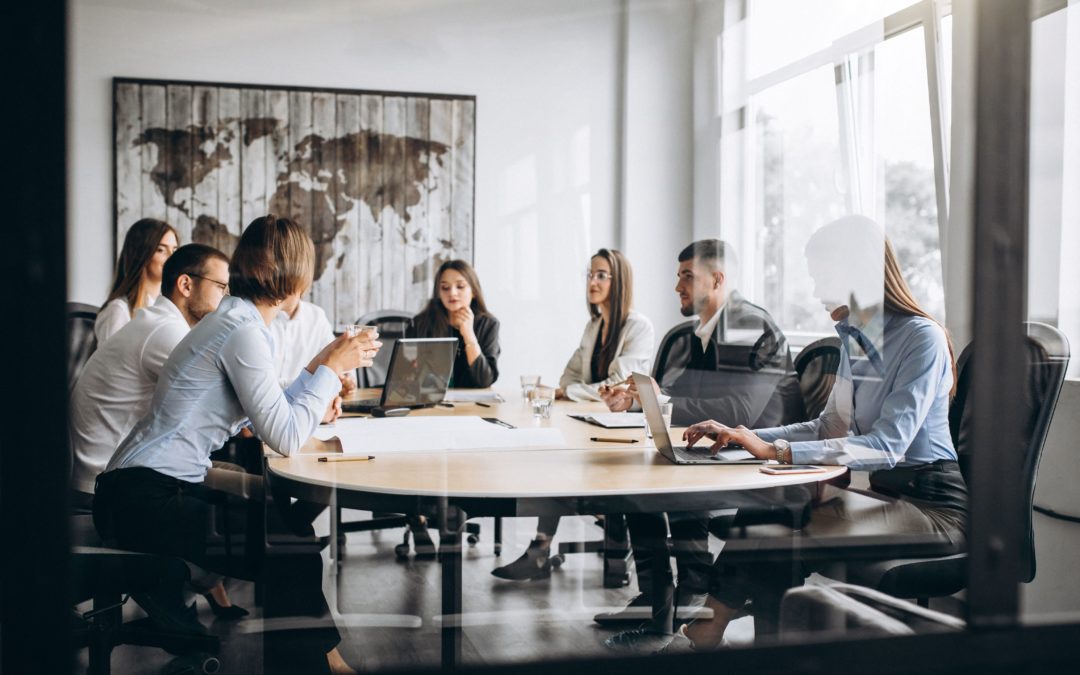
[{"xmin": 848, "ymin": 322, "xmax": 1070, "ymax": 607}]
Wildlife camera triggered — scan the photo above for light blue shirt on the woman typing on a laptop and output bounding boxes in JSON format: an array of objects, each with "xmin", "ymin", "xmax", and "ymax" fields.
[{"xmin": 756, "ymin": 312, "xmax": 956, "ymax": 471}]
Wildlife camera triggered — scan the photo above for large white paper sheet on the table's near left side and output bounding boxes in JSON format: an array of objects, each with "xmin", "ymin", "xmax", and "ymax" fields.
[{"xmin": 315, "ymin": 417, "xmax": 566, "ymax": 455}]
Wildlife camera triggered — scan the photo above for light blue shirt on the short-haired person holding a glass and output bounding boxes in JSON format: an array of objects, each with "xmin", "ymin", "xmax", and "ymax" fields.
[{"xmin": 106, "ymin": 297, "xmax": 341, "ymax": 483}]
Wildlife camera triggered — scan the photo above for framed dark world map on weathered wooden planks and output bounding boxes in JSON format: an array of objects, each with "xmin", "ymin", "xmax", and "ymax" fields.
[{"xmin": 112, "ymin": 78, "xmax": 476, "ymax": 325}]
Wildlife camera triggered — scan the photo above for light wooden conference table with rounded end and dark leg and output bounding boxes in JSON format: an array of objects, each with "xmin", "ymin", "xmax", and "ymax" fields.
[{"xmin": 267, "ymin": 390, "xmax": 847, "ymax": 669}]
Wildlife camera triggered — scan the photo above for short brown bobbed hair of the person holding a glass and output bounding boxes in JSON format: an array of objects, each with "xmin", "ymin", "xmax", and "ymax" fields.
[{"xmin": 229, "ymin": 214, "xmax": 315, "ymax": 302}]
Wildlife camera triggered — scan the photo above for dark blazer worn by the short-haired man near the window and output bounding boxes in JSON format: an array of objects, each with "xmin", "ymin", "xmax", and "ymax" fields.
[{"xmin": 657, "ymin": 292, "xmax": 805, "ymax": 429}]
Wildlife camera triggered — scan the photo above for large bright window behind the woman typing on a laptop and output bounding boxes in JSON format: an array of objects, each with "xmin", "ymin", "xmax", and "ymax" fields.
[{"xmin": 718, "ymin": 0, "xmax": 947, "ymax": 340}]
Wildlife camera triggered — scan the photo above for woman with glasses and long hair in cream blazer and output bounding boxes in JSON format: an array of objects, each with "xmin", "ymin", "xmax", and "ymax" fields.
[{"xmin": 491, "ymin": 248, "xmax": 652, "ymax": 581}]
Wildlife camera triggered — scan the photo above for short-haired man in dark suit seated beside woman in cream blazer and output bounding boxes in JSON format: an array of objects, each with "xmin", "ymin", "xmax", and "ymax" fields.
[{"xmin": 595, "ymin": 239, "xmax": 804, "ymax": 649}]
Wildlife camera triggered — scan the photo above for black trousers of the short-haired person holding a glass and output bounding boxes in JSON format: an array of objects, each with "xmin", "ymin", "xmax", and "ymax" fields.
[{"xmin": 94, "ymin": 468, "xmax": 340, "ymax": 672}]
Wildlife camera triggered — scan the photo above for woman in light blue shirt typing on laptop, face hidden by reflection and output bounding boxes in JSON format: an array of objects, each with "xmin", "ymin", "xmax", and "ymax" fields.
[{"xmin": 608, "ymin": 216, "xmax": 968, "ymax": 650}]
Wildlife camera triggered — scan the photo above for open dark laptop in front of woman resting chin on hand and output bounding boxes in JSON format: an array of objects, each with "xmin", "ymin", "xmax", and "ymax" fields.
[{"xmin": 341, "ymin": 338, "xmax": 458, "ymax": 416}]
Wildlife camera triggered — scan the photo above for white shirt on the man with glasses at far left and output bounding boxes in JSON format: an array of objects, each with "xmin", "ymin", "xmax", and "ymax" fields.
[{"xmin": 68, "ymin": 296, "xmax": 190, "ymax": 494}]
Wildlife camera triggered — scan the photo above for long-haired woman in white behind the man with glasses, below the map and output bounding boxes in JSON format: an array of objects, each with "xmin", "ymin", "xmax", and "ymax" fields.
[{"xmin": 94, "ymin": 218, "xmax": 179, "ymax": 345}]
